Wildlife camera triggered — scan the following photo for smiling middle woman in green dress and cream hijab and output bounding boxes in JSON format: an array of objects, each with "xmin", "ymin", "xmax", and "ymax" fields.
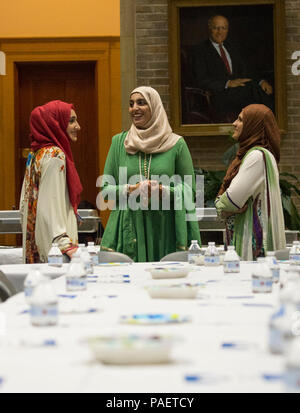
[{"xmin": 97, "ymin": 86, "xmax": 200, "ymax": 262}]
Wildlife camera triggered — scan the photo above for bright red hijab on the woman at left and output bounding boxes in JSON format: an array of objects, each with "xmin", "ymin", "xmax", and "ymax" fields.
[{"xmin": 30, "ymin": 100, "xmax": 83, "ymax": 214}]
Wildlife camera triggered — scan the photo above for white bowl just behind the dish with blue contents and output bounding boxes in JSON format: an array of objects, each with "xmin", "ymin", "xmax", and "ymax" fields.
[{"xmin": 145, "ymin": 283, "xmax": 202, "ymax": 298}]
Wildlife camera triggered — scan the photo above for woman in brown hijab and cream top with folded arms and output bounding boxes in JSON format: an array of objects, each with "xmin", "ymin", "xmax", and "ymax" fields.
[{"xmin": 215, "ymin": 104, "xmax": 286, "ymax": 260}]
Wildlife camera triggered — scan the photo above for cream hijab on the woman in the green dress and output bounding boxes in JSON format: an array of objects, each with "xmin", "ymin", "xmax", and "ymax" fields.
[{"xmin": 124, "ymin": 86, "xmax": 180, "ymax": 155}]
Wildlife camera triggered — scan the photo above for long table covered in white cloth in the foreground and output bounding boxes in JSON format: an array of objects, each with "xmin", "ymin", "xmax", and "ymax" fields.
[{"xmin": 0, "ymin": 262, "xmax": 292, "ymax": 393}]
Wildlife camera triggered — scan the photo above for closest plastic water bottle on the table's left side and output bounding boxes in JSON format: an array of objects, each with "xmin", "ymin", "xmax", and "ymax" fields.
[{"xmin": 30, "ymin": 279, "xmax": 58, "ymax": 326}]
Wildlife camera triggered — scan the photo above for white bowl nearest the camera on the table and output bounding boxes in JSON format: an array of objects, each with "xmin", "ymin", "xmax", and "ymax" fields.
[{"xmin": 88, "ymin": 335, "xmax": 172, "ymax": 365}]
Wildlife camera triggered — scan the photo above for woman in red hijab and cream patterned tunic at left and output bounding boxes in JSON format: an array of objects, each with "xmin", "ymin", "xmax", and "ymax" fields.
[{"xmin": 20, "ymin": 100, "xmax": 82, "ymax": 263}]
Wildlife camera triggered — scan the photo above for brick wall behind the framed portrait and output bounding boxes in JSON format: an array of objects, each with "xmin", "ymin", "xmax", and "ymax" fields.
[{"xmin": 121, "ymin": 0, "xmax": 300, "ymax": 208}]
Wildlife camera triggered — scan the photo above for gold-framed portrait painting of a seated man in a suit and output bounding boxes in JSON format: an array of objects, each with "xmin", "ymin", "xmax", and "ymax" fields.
[{"xmin": 169, "ymin": 0, "xmax": 286, "ymax": 136}]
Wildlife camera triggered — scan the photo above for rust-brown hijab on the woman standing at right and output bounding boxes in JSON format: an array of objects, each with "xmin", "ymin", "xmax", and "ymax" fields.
[{"xmin": 218, "ymin": 104, "xmax": 280, "ymax": 195}]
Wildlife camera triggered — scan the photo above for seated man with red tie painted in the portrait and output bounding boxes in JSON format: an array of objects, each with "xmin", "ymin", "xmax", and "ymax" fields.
[{"xmin": 191, "ymin": 15, "xmax": 274, "ymax": 122}]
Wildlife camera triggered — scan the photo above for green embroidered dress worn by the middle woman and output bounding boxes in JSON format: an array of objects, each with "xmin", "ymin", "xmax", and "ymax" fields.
[{"xmin": 101, "ymin": 132, "xmax": 200, "ymax": 262}]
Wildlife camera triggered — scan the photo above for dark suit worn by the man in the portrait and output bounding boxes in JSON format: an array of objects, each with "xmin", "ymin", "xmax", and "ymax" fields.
[{"xmin": 191, "ymin": 39, "xmax": 273, "ymax": 119}]
